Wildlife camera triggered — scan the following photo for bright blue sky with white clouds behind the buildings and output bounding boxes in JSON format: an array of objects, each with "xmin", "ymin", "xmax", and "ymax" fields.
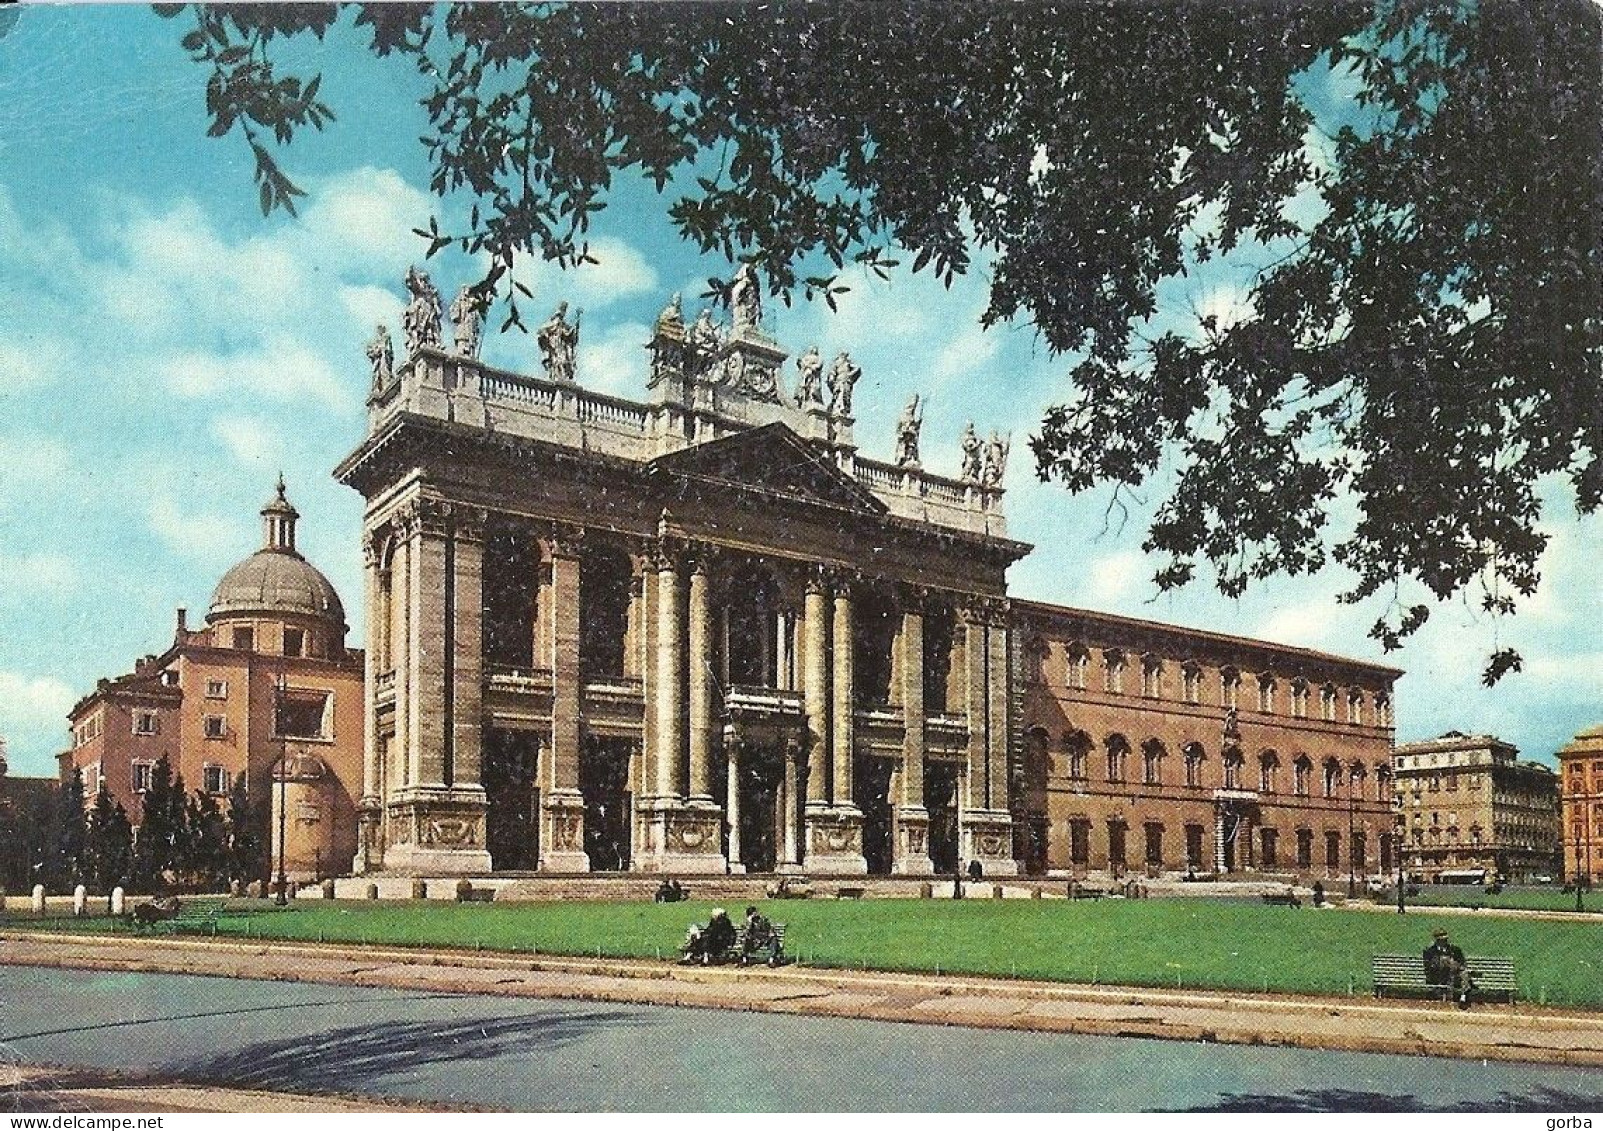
[{"xmin": 0, "ymin": 5, "xmax": 1603, "ymax": 774}]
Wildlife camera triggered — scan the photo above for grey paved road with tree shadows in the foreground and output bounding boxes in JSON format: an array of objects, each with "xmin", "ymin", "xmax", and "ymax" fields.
[{"xmin": 0, "ymin": 968, "xmax": 1603, "ymax": 1112}]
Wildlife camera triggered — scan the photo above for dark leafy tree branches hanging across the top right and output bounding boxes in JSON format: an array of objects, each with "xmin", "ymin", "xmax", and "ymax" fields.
[{"xmin": 164, "ymin": 0, "xmax": 1603, "ymax": 681}]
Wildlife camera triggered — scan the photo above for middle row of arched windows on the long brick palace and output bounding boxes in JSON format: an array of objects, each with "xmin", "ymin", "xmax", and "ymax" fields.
[{"xmin": 1034, "ymin": 731, "xmax": 1391, "ymax": 801}]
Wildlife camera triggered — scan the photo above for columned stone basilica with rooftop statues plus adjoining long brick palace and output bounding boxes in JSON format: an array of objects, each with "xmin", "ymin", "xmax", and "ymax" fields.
[{"xmin": 337, "ymin": 269, "xmax": 1399, "ymax": 876}]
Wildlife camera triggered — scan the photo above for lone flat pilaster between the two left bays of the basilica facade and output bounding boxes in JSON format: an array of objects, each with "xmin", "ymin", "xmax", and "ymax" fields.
[{"xmin": 540, "ymin": 525, "xmax": 590, "ymax": 871}]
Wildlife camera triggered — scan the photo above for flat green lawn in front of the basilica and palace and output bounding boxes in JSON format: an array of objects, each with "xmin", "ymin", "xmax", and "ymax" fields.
[{"xmin": 0, "ymin": 899, "xmax": 1603, "ymax": 1006}]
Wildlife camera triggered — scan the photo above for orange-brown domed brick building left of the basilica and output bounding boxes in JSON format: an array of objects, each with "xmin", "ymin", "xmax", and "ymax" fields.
[{"xmin": 58, "ymin": 479, "xmax": 364, "ymax": 881}]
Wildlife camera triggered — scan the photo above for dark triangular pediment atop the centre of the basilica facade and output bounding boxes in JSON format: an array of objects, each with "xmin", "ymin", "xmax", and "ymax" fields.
[{"xmin": 648, "ymin": 423, "xmax": 888, "ymax": 514}]
